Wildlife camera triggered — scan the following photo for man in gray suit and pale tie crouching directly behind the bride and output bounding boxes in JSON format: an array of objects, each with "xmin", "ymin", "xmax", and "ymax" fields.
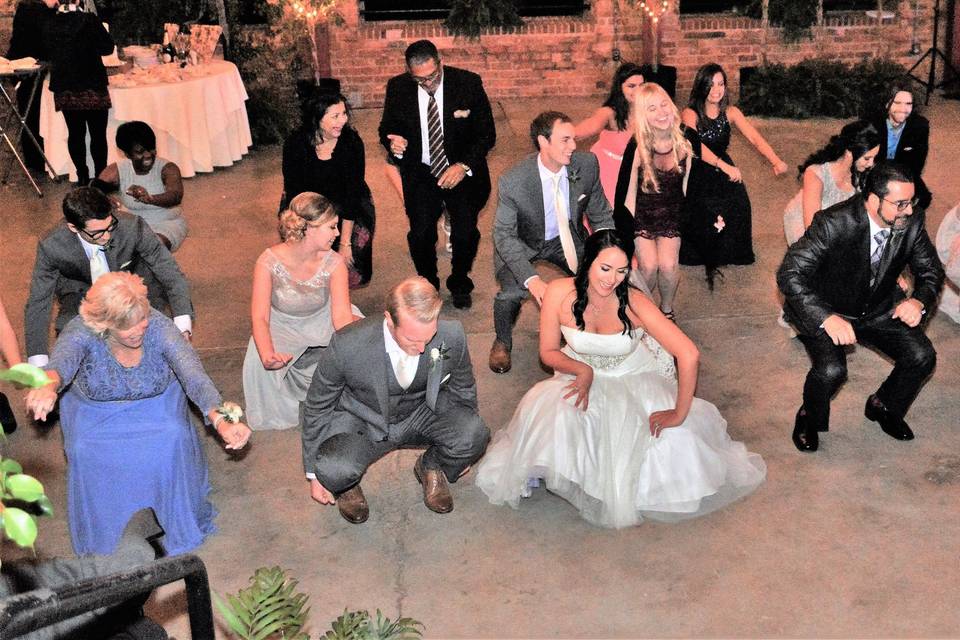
[{"xmin": 490, "ymin": 111, "xmax": 613, "ymax": 373}]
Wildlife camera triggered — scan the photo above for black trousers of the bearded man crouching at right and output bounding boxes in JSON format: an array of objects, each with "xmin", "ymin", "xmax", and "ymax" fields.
[{"xmin": 798, "ymin": 313, "xmax": 937, "ymax": 428}]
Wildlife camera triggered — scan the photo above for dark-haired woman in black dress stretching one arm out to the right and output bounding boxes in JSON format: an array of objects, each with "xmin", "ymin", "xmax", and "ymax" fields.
[{"xmin": 680, "ymin": 63, "xmax": 787, "ymax": 290}]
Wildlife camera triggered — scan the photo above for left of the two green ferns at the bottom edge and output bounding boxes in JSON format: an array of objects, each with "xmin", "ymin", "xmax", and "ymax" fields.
[{"xmin": 213, "ymin": 567, "xmax": 310, "ymax": 640}]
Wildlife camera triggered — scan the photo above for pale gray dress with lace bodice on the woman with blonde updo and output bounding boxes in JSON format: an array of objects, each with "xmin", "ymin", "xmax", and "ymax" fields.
[{"xmin": 243, "ymin": 249, "xmax": 343, "ymax": 429}]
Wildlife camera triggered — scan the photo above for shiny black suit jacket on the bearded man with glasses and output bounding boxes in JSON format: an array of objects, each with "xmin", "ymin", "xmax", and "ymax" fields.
[{"xmin": 777, "ymin": 194, "xmax": 943, "ymax": 335}]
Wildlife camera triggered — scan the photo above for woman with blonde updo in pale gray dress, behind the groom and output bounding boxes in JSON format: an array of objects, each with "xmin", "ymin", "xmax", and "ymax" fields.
[{"xmin": 243, "ymin": 192, "xmax": 359, "ymax": 429}]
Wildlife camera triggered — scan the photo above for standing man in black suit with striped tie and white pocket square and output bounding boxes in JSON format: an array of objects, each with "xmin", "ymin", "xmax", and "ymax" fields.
[{"xmin": 380, "ymin": 40, "xmax": 496, "ymax": 309}]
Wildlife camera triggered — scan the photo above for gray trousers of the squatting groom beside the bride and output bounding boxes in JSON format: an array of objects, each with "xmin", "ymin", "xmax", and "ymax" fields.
[{"xmin": 314, "ymin": 405, "xmax": 490, "ymax": 495}]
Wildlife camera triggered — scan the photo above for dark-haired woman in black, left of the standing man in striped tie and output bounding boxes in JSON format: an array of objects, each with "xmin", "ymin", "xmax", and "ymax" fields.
[{"xmin": 280, "ymin": 92, "xmax": 376, "ymax": 289}]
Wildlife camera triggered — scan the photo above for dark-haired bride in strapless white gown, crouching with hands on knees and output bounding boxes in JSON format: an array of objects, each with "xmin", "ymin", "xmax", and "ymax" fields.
[{"xmin": 476, "ymin": 231, "xmax": 766, "ymax": 528}]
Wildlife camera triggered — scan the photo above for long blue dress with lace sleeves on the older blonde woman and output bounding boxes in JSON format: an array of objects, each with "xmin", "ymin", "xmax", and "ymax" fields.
[{"xmin": 47, "ymin": 310, "xmax": 221, "ymax": 555}]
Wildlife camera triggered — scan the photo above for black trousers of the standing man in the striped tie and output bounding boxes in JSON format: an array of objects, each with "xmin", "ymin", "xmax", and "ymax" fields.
[{"xmin": 402, "ymin": 163, "xmax": 488, "ymax": 293}]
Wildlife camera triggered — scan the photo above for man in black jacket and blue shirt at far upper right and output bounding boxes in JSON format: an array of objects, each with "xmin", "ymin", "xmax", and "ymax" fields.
[{"xmin": 873, "ymin": 84, "xmax": 933, "ymax": 211}]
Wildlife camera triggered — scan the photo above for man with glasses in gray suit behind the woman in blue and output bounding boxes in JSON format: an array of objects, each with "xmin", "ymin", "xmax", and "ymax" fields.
[{"xmin": 24, "ymin": 187, "xmax": 193, "ymax": 367}]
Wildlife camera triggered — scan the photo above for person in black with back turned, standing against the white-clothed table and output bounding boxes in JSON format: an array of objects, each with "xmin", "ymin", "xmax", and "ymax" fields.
[{"xmin": 43, "ymin": 0, "xmax": 113, "ymax": 186}]
